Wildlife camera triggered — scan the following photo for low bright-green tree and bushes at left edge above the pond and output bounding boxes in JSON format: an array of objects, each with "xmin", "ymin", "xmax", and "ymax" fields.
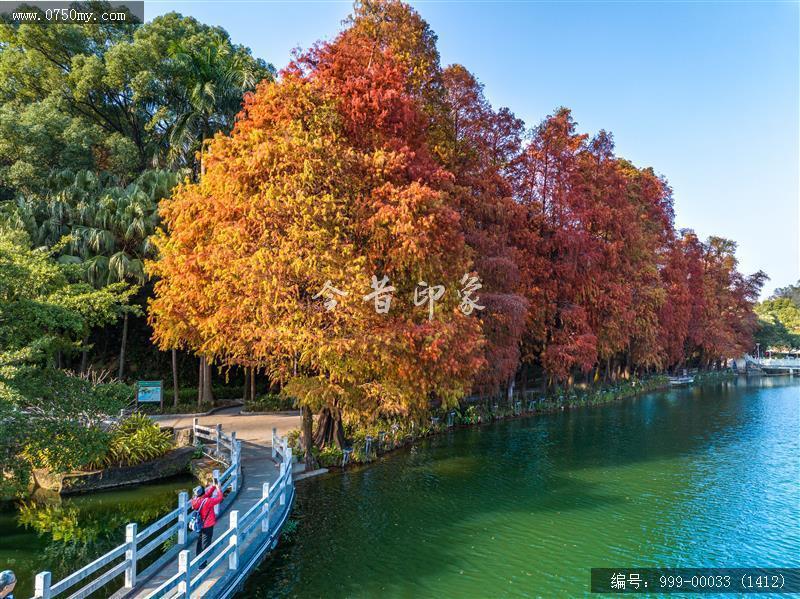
[{"xmin": 0, "ymin": 222, "xmax": 133, "ymax": 496}]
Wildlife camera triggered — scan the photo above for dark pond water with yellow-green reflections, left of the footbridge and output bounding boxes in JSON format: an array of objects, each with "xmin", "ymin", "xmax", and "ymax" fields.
[{"xmin": 0, "ymin": 476, "xmax": 192, "ymax": 597}]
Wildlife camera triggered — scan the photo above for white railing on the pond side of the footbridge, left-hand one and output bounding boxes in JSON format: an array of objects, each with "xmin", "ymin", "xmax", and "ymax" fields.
[{"xmin": 34, "ymin": 418, "xmax": 242, "ymax": 599}]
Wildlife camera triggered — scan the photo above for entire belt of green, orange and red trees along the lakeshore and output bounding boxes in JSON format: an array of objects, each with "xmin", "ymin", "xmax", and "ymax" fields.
[{"xmin": 0, "ymin": 1, "xmax": 788, "ymax": 488}]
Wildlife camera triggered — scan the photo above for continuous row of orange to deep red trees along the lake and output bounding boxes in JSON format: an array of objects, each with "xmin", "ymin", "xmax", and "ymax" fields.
[{"xmin": 149, "ymin": 0, "xmax": 765, "ymax": 464}]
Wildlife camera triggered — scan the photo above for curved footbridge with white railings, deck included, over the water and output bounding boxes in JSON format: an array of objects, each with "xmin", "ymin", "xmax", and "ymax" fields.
[{"xmin": 34, "ymin": 418, "xmax": 294, "ymax": 599}]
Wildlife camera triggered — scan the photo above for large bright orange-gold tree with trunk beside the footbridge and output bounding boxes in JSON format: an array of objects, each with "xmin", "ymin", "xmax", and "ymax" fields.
[{"xmin": 149, "ymin": 15, "xmax": 483, "ymax": 464}]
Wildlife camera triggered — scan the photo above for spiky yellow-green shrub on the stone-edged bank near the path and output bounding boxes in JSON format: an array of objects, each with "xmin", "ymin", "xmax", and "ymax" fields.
[{"xmin": 103, "ymin": 413, "xmax": 174, "ymax": 467}]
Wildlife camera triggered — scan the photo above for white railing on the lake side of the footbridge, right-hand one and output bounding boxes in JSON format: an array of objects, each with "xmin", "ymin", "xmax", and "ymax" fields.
[{"xmin": 147, "ymin": 429, "xmax": 294, "ymax": 599}]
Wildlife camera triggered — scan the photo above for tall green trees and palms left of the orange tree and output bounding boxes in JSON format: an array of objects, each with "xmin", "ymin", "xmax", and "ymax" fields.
[{"xmin": 0, "ymin": 8, "xmax": 274, "ymax": 401}]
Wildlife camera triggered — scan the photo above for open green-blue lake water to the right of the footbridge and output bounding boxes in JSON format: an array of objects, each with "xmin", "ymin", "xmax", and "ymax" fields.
[{"xmin": 244, "ymin": 378, "xmax": 800, "ymax": 599}]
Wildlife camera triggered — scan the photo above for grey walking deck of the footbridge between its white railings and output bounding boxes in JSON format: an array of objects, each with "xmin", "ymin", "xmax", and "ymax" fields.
[{"xmin": 123, "ymin": 442, "xmax": 289, "ymax": 599}]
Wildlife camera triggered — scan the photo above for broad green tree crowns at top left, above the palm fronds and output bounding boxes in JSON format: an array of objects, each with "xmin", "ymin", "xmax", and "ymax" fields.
[{"xmin": 0, "ymin": 6, "xmax": 274, "ymax": 198}]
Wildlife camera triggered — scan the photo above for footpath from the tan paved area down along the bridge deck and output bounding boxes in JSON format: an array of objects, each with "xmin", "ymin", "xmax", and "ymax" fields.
[{"xmin": 124, "ymin": 407, "xmax": 300, "ymax": 599}]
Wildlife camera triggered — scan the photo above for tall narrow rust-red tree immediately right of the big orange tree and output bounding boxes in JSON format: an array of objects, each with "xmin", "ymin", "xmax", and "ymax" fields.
[{"xmin": 438, "ymin": 65, "xmax": 527, "ymax": 392}]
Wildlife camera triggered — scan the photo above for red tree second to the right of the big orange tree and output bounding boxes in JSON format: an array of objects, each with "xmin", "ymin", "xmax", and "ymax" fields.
[{"xmin": 516, "ymin": 109, "xmax": 600, "ymax": 380}]
